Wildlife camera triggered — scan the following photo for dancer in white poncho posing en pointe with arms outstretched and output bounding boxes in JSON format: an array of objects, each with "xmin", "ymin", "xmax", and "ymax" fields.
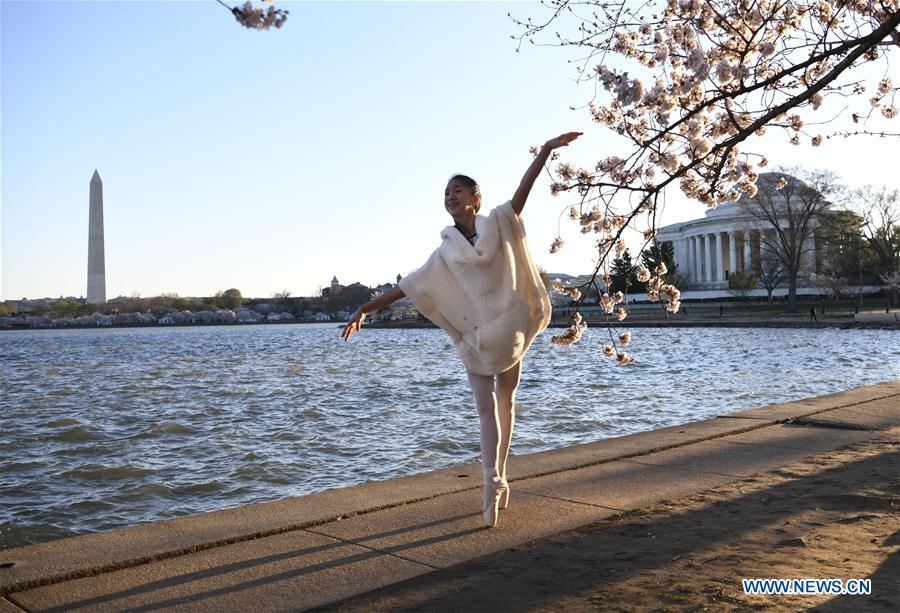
[{"xmin": 343, "ymin": 132, "xmax": 582, "ymax": 527}]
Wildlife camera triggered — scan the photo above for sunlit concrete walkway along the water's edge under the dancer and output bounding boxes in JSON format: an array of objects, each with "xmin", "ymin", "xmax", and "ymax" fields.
[{"xmin": 0, "ymin": 381, "xmax": 900, "ymax": 613}]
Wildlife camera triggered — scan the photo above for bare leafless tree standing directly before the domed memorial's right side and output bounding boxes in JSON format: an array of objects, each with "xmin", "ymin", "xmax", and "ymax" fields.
[{"xmin": 738, "ymin": 170, "xmax": 840, "ymax": 313}]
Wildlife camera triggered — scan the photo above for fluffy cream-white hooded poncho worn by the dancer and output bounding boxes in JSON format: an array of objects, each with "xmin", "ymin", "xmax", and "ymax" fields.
[{"xmin": 399, "ymin": 201, "xmax": 551, "ymax": 375}]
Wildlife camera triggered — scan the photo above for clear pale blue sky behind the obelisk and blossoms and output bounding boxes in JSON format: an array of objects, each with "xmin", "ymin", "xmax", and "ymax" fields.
[{"xmin": 0, "ymin": 0, "xmax": 898, "ymax": 300}]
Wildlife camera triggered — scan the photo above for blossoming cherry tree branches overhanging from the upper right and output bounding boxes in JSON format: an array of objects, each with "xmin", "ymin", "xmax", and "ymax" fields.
[{"xmin": 514, "ymin": 0, "xmax": 900, "ymax": 354}]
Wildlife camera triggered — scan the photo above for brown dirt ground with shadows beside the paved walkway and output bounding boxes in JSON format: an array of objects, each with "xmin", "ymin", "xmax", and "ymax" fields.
[{"xmin": 317, "ymin": 428, "xmax": 900, "ymax": 612}]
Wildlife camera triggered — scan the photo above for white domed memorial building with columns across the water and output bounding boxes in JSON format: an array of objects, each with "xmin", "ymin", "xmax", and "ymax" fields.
[{"xmin": 656, "ymin": 173, "xmax": 821, "ymax": 290}]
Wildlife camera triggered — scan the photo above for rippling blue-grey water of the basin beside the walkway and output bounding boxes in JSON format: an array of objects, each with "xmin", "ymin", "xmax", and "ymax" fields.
[{"xmin": 0, "ymin": 324, "xmax": 900, "ymax": 548}]
